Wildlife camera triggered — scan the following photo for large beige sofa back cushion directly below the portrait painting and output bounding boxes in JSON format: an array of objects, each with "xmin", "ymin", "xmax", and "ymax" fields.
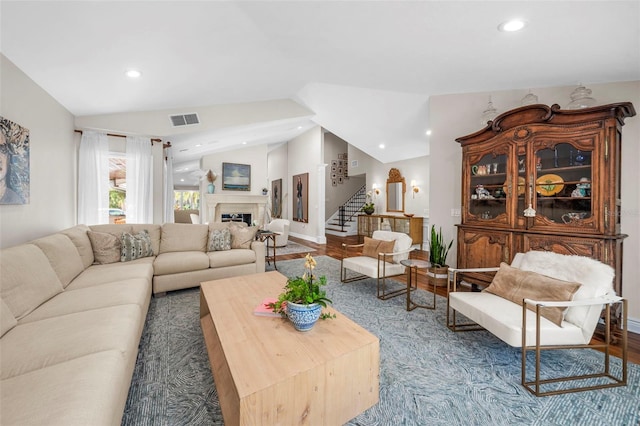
[{"xmin": 0, "ymin": 244, "xmax": 64, "ymax": 320}]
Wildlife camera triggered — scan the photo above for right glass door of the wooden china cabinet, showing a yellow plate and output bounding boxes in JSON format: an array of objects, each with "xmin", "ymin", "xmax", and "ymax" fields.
[{"xmin": 533, "ymin": 143, "xmax": 593, "ymax": 226}]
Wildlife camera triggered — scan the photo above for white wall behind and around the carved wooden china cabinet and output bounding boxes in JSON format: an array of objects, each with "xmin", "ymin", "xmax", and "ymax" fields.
[{"xmin": 429, "ymin": 81, "xmax": 640, "ymax": 326}]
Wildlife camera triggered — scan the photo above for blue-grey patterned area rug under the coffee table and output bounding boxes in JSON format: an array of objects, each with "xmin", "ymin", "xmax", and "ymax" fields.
[{"xmin": 122, "ymin": 256, "xmax": 640, "ymax": 426}]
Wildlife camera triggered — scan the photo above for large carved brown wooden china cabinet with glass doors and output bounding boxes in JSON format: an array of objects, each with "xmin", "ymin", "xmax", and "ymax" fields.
[{"xmin": 456, "ymin": 102, "xmax": 636, "ymax": 302}]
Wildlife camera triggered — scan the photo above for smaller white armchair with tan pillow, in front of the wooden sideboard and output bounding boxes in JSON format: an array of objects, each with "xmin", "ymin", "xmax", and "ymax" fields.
[{"xmin": 340, "ymin": 231, "xmax": 413, "ymax": 300}]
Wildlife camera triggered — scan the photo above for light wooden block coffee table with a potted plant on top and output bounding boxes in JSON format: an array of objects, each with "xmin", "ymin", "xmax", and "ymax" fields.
[{"xmin": 200, "ymin": 272, "xmax": 380, "ymax": 425}]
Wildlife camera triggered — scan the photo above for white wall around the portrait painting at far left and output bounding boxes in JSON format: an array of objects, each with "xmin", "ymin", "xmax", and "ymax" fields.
[{"xmin": 0, "ymin": 54, "xmax": 79, "ymax": 247}]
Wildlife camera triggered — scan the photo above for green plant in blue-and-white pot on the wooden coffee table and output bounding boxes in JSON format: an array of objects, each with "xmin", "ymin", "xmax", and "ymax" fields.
[{"xmin": 269, "ymin": 253, "xmax": 335, "ymax": 331}]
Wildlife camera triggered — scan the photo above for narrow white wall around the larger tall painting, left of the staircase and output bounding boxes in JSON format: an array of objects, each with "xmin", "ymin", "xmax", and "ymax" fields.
[{"xmin": 283, "ymin": 127, "xmax": 326, "ymax": 244}]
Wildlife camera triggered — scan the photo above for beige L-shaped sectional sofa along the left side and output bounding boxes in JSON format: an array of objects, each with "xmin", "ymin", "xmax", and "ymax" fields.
[{"xmin": 0, "ymin": 224, "xmax": 264, "ymax": 426}]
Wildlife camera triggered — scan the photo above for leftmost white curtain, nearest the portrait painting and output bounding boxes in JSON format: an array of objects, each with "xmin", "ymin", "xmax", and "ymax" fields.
[{"xmin": 78, "ymin": 130, "xmax": 109, "ymax": 225}]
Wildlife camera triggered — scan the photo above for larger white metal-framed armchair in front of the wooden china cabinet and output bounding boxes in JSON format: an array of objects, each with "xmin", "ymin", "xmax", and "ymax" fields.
[{"xmin": 447, "ymin": 251, "xmax": 627, "ymax": 396}]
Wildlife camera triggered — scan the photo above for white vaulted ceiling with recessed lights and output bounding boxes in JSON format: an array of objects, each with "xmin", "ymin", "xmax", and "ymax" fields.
[{"xmin": 0, "ymin": 0, "xmax": 640, "ymax": 185}]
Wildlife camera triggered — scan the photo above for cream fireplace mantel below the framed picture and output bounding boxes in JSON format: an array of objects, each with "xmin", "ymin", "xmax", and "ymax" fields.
[{"xmin": 205, "ymin": 194, "xmax": 269, "ymax": 225}]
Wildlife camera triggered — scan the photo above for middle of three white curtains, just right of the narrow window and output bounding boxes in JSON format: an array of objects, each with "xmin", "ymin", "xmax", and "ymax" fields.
[{"xmin": 126, "ymin": 136, "xmax": 153, "ymax": 223}]
